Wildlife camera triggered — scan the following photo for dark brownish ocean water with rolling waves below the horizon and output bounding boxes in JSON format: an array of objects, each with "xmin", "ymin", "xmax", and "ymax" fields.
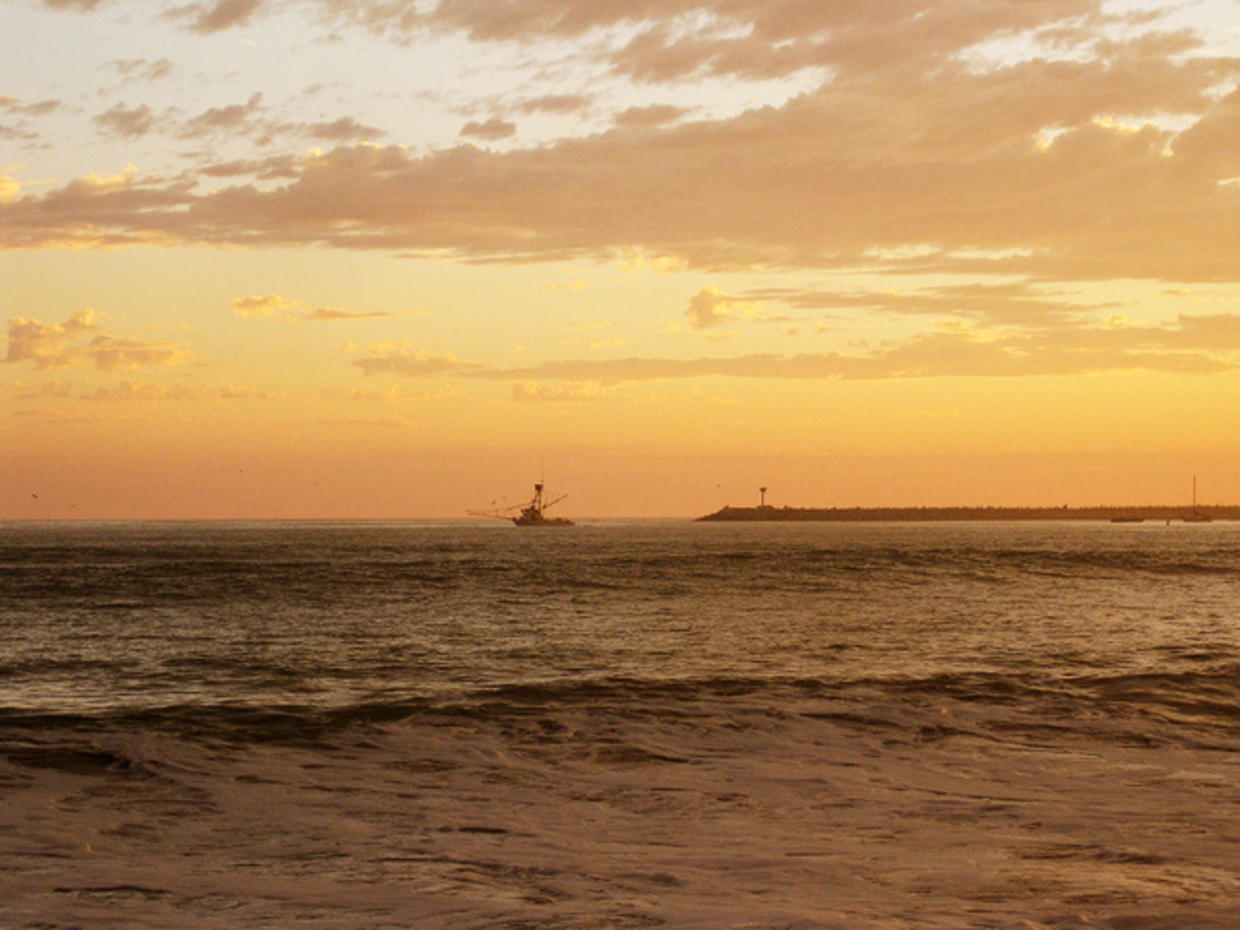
[{"xmin": 0, "ymin": 522, "xmax": 1240, "ymax": 930}]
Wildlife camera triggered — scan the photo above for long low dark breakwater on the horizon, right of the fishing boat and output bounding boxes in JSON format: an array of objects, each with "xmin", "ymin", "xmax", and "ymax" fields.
[{"xmin": 697, "ymin": 505, "xmax": 1240, "ymax": 523}]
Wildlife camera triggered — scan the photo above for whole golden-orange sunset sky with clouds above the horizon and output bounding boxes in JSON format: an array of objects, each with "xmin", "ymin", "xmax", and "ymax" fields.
[{"xmin": 0, "ymin": 0, "xmax": 1240, "ymax": 520}]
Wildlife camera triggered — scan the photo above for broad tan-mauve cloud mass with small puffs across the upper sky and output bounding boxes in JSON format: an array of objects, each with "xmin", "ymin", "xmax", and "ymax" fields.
[{"xmin": 0, "ymin": 0, "xmax": 1240, "ymax": 291}]
